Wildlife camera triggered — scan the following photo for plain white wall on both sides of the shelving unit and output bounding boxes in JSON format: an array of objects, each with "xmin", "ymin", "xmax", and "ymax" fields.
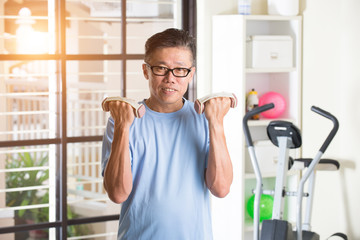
[{"xmin": 197, "ymin": 0, "xmax": 360, "ymax": 239}]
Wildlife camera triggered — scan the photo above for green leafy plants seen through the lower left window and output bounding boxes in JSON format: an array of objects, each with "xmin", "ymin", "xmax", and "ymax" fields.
[{"xmin": 6, "ymin": 152, "xmax": 90, "ymax": 237}]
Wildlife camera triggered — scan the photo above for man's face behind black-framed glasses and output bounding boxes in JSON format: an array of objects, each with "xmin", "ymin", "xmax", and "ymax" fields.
[{"xmin": 143, "ymin": 47, "xmax": 195, "ymax": 112}]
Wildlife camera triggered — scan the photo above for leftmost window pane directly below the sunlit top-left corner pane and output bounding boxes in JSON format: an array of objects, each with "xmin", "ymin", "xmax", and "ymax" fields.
[{"xmin": 0, "ymin": 61, "xmax": 58, "ymax": 141}]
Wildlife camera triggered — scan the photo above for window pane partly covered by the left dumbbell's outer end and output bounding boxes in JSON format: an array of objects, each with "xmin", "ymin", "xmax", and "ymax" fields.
[{"xmin": 66, "ymin": 61, "xmax": 122, "ymax": 137}]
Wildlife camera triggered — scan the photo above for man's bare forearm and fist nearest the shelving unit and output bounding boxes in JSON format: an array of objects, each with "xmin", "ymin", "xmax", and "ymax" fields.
[{"xmin": 205, "ymin": 97, "xmax": 233, "ymax": 198}]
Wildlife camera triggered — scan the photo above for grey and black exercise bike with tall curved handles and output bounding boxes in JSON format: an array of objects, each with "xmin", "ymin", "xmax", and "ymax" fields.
[{"xmin": 243, "ymin": 103, "xmax": 347, "ymax": 240}]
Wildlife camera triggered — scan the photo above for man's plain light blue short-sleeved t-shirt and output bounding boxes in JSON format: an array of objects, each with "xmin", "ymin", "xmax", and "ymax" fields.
[{"xmin": 102, "ymin": 100, "xmax": 212, "ymax": 240}]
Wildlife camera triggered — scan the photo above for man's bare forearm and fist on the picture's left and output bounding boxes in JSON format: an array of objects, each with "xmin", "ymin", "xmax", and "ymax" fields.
[{"xmin": 103, "ymin": 101, "xmax": 134, "ymax": 203}]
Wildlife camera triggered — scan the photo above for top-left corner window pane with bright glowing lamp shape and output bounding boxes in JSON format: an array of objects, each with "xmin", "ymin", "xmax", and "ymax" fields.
[{"xmin": 0, "ymin": 1, "xmax": 57, "ymax": 54}]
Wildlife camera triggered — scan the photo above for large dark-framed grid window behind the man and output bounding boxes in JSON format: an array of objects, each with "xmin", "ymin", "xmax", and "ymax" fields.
[{"xmin": 0, "ymin": 0, "xmax": 195, "ymax": 239}]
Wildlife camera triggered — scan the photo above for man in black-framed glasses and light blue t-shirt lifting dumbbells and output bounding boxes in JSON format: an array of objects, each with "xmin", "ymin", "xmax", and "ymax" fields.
[{"xmin": 102, "ymin": 29, "xmax": 233, "ymax": 240}]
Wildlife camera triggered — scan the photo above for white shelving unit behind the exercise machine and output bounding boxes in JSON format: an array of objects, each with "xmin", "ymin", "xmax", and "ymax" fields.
[{"xmin": 212, "ymin": 15, "xmax": 302, "ymax": 239}]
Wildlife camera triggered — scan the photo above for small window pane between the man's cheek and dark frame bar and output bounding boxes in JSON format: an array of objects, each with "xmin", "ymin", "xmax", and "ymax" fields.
[{"xmin": 126, "ymin": 60, "xmax": 150, "ymax": 101}]
